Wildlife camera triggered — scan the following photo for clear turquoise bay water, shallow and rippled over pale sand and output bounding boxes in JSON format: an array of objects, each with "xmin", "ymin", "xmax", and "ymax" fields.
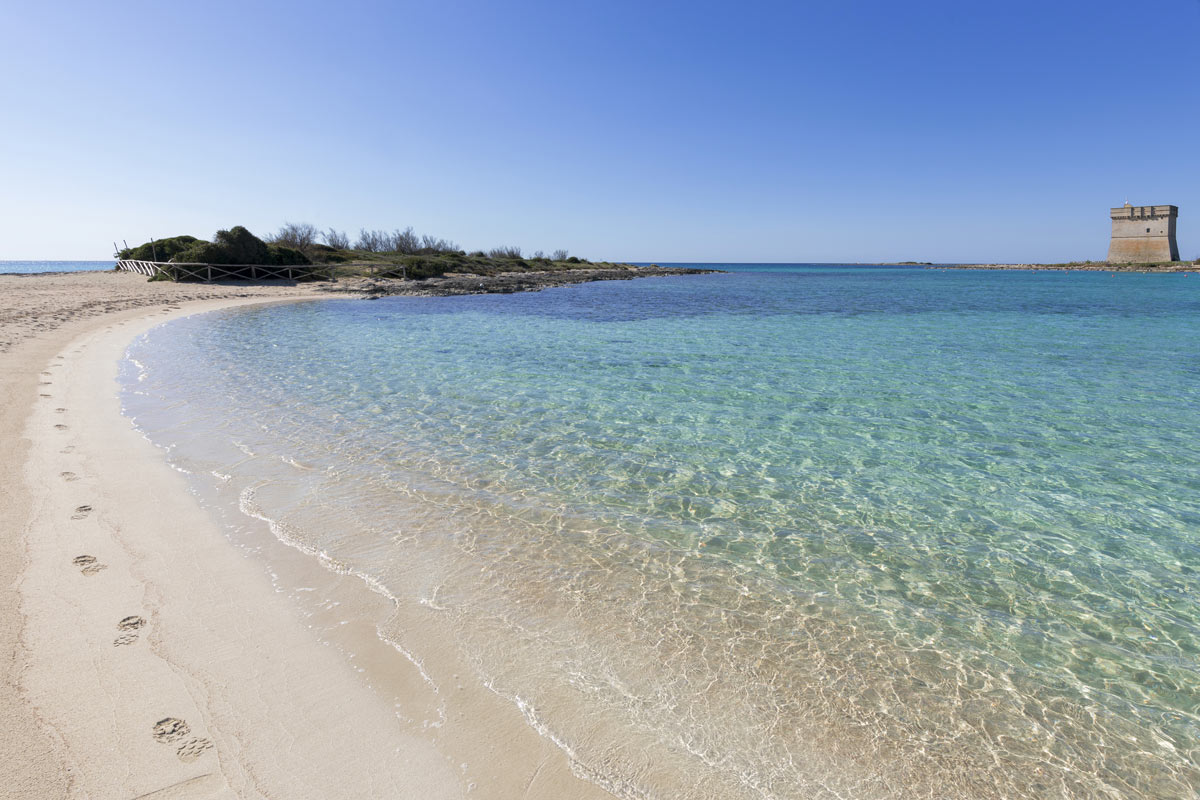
[{"xmin": 119, "ymin": 265, "xmax": 1200, "ymax": 800}]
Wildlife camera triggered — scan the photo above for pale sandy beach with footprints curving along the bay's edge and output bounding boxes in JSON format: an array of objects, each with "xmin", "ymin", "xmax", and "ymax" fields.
[{"xmin": 0, "ymin": 273, "xmax": 610, "ymax": 800}]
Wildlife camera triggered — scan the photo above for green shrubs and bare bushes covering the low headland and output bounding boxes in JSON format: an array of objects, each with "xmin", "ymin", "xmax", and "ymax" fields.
[{"xmin": 118, "ymin": 222, "xmax": 601, "ymax": 281}]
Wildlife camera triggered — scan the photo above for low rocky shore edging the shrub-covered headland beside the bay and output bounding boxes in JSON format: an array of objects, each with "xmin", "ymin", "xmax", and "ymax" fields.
[{"xmin": 321, "ymin": 266, "xmax": 721, "ymax": 299}]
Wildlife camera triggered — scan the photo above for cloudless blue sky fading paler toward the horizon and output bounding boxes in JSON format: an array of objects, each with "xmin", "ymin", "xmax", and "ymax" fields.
[{"xmin": 0, "ymin": 0, "xmax": 1200, "ymax": 261}]
